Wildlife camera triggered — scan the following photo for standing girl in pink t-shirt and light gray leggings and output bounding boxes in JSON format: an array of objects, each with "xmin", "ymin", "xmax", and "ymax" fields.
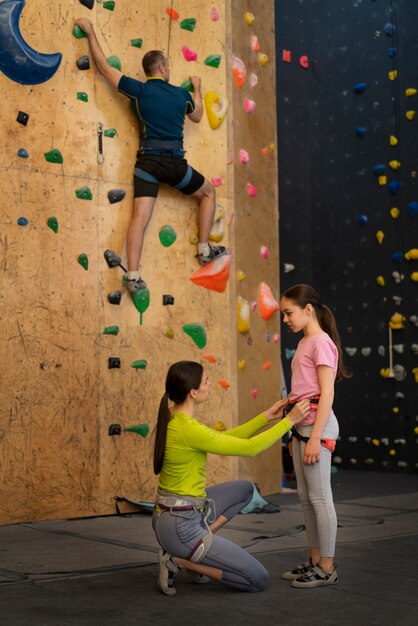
[{"xmin": 280, "ymin": 285, "xmax": 350, "ymax": 588}]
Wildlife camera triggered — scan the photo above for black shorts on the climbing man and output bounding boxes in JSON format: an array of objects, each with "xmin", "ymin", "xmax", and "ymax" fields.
[{"xmin": 134, "ymin": 154, "xmax": 205, "ymax": 198}]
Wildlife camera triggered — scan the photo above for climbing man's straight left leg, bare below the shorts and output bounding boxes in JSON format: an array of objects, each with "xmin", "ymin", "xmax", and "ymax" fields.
[{"xmin": 126, "ymin": 197, "xmax": 156, "ymax": 291}]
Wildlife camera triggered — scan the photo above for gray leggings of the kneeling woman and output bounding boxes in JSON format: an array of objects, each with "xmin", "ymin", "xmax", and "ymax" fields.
[{"xmin": 152, "ymin": 480, "xmax": 268, "ymax": 592}]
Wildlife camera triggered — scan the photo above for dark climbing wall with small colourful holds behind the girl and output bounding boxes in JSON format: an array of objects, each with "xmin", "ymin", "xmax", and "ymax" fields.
[{"xmin": 275, "ymin": 0, "xmax": 418, "ymax": 471}]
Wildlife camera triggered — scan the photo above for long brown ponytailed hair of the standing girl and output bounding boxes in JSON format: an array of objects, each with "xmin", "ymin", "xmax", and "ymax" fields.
[{"xmin": 281, "ymin": 284, "xmax": 352, "ymax": 380}]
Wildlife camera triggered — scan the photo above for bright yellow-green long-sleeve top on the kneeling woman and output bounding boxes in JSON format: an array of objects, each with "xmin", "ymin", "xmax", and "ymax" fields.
[{"xmin": 159, "ymin": 413, "xmax": 292, "ymax": 498}]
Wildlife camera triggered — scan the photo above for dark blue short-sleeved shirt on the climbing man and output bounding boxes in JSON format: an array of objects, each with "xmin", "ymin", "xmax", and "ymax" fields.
[{"xmin": 118, "ymin": 76, "xmax": 195, "ymax": 147}]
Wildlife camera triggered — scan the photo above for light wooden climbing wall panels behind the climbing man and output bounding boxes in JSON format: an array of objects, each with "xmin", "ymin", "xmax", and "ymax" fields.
[{"xmin": 0, "ymin": 0, "xmax": 281, "ymax": 523}]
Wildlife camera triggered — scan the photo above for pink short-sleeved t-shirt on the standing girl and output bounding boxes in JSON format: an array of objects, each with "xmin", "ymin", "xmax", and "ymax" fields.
[{"xmin": 289, "ymin": 333, "xmax": 338, "ymax": 426}]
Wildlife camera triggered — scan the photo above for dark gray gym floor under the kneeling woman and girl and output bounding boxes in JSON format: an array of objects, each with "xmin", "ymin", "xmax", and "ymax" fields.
[{"xmin": 0, "ymin": 471, "xmax": 418, "ymax": 626}]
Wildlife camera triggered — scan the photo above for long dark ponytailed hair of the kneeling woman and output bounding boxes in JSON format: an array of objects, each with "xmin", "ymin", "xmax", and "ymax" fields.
[{"xmin": 154, "ymin": 361, "xmax": 203, "ymax": 474}]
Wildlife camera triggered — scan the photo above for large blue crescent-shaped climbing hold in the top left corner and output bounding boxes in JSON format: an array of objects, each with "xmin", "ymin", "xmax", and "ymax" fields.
[{"xmin": 0, "ymin": 0, "xmax": 62, "ymax": 85}]
